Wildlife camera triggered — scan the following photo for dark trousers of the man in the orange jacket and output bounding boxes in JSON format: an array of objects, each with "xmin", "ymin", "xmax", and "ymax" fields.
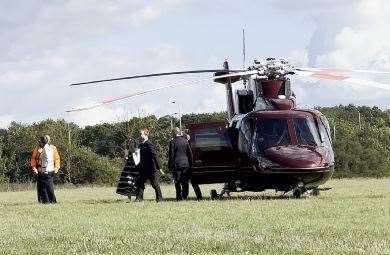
[{"xmin": 37, "ymin": 173, "xmax": 57, "ymax": 204}]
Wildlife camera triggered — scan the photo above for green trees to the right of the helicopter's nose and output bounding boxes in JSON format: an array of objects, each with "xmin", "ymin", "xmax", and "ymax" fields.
[{"xmin": 318, "ymin": 105, "xmax": 390, "ymax": 177}]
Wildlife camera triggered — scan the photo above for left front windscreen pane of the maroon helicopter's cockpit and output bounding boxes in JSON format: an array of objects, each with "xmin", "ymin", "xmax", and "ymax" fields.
[{"xmin": 254, "ymin": 119, "xmax": 291, "ymax": 153}]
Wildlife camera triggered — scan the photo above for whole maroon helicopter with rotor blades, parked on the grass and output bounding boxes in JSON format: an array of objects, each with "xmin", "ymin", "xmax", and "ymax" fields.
[{"xmin": 68, "ymin": 58, "xmax": 390, "ymax": 199}]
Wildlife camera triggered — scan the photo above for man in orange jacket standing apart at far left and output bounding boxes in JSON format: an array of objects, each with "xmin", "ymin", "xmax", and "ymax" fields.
[{"xmin": 30, "ymin": 135, "xmax": 60, "ymax": 203}]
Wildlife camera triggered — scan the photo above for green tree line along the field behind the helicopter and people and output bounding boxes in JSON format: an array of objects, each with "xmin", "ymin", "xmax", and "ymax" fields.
[{"xmin": 0, "ymin": 105, "xmax": 390, "ymax": 184}]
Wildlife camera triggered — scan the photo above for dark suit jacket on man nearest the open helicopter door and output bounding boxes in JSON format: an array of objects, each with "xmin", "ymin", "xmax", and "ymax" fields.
[{"xmin": 168, "ymin": 136, "xmax": 192, "ymax": 172}]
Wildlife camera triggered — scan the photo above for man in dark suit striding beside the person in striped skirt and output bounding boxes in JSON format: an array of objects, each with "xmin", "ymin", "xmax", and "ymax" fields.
[{"xmin": 136, "ymin": 129, "xmax": 162, "ymax": 202}]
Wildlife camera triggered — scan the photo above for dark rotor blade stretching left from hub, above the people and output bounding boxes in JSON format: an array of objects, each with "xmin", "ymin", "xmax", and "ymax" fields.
[{"xmin": 69, "ymin": 69, "xmax": 243, "ymax": 86}]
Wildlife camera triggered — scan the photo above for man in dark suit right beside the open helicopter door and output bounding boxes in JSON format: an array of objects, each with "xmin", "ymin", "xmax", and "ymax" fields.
[{"xmin": 168, "ymin": 128, "xmax": 197, "ymax": 200}]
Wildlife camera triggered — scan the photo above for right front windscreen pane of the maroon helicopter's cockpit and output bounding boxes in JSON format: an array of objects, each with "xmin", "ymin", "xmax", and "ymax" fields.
[{"xmin": 294, "ymin": 118, "xmax": 321, "ymax": 146}]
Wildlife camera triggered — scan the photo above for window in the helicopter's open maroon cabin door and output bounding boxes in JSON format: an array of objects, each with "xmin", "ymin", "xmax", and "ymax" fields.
[{"xmin": 191, "ymin": 127, "xmax": 230, "ymax": 148}]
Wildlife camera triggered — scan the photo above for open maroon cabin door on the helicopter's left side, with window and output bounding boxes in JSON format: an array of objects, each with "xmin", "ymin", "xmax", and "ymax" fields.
[{"xmin": 188, "ymin": 122, "xmax": 238, "ymax": 184}]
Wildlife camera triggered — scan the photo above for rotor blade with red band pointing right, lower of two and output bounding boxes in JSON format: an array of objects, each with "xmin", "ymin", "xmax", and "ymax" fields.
[{"xmin": 295, "ymin": 69, "xmax": 390, "ymax": 90}]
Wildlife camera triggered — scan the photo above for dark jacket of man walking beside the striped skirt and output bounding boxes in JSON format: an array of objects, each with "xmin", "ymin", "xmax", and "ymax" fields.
[{"xmin": 139, "ymin": 140, "xmax": 160, "ymax": 175}]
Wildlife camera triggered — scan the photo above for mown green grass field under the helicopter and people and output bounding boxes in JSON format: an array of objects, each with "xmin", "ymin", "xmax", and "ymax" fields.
[{"xmin": 0, "ymin": 179, "xmax": 390, "ymax": 254}]
